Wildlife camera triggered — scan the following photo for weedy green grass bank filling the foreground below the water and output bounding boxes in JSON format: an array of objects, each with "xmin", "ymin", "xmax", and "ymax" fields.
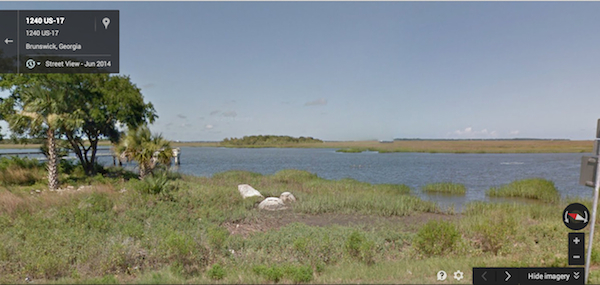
[{"xmin": 0, "ymin": 155, "xmax": 600, "ymax": 284}]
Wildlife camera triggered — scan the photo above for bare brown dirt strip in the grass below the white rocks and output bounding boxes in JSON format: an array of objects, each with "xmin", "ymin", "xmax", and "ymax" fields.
[{"xmin": 223, "ymin": 210, "xmax": 460, "ymax": 237}]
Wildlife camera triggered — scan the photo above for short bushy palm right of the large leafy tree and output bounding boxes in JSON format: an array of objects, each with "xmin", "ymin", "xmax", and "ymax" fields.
[{"xmin": 116, "ymin": 125, "xmax": 173, "ymax": 179}]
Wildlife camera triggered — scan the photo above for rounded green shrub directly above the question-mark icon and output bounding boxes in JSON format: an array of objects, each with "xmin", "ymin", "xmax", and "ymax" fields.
[{"xmin": 413, "ymin": 220, "xmax": 460, "ymax": 256}]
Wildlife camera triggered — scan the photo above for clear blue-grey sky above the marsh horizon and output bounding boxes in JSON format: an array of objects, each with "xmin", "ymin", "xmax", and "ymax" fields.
[{"xmin": 0, "ymin": 2, "xmax": 600, "ymax": 141}]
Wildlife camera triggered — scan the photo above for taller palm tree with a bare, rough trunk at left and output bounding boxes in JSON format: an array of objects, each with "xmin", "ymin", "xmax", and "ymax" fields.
[{"xmin": 8, "ymin": 82, "xmax": 80, "ymax": 190}]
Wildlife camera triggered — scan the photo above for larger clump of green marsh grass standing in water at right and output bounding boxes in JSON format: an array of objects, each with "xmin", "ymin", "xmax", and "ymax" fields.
[{"xmin": 487, "ymin": 178, "xmax": 560, "ymax": 203}]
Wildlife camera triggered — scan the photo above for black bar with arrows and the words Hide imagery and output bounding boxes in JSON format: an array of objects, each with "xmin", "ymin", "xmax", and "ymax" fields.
[{"xmin": 473, "ymin": 267, "xmax": 585, "ymax": 285}]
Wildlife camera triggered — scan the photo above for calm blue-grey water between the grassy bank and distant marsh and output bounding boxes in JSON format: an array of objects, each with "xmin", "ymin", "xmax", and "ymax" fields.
[{"xmin": 0, "ymin": 147, "xmax": 593, "ymax": 208}]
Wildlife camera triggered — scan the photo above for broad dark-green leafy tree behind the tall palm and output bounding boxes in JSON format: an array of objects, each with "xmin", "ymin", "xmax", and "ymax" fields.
[{"xmin": 0, "ymin": 74, "xmax": 158, "ymax": 175}]
